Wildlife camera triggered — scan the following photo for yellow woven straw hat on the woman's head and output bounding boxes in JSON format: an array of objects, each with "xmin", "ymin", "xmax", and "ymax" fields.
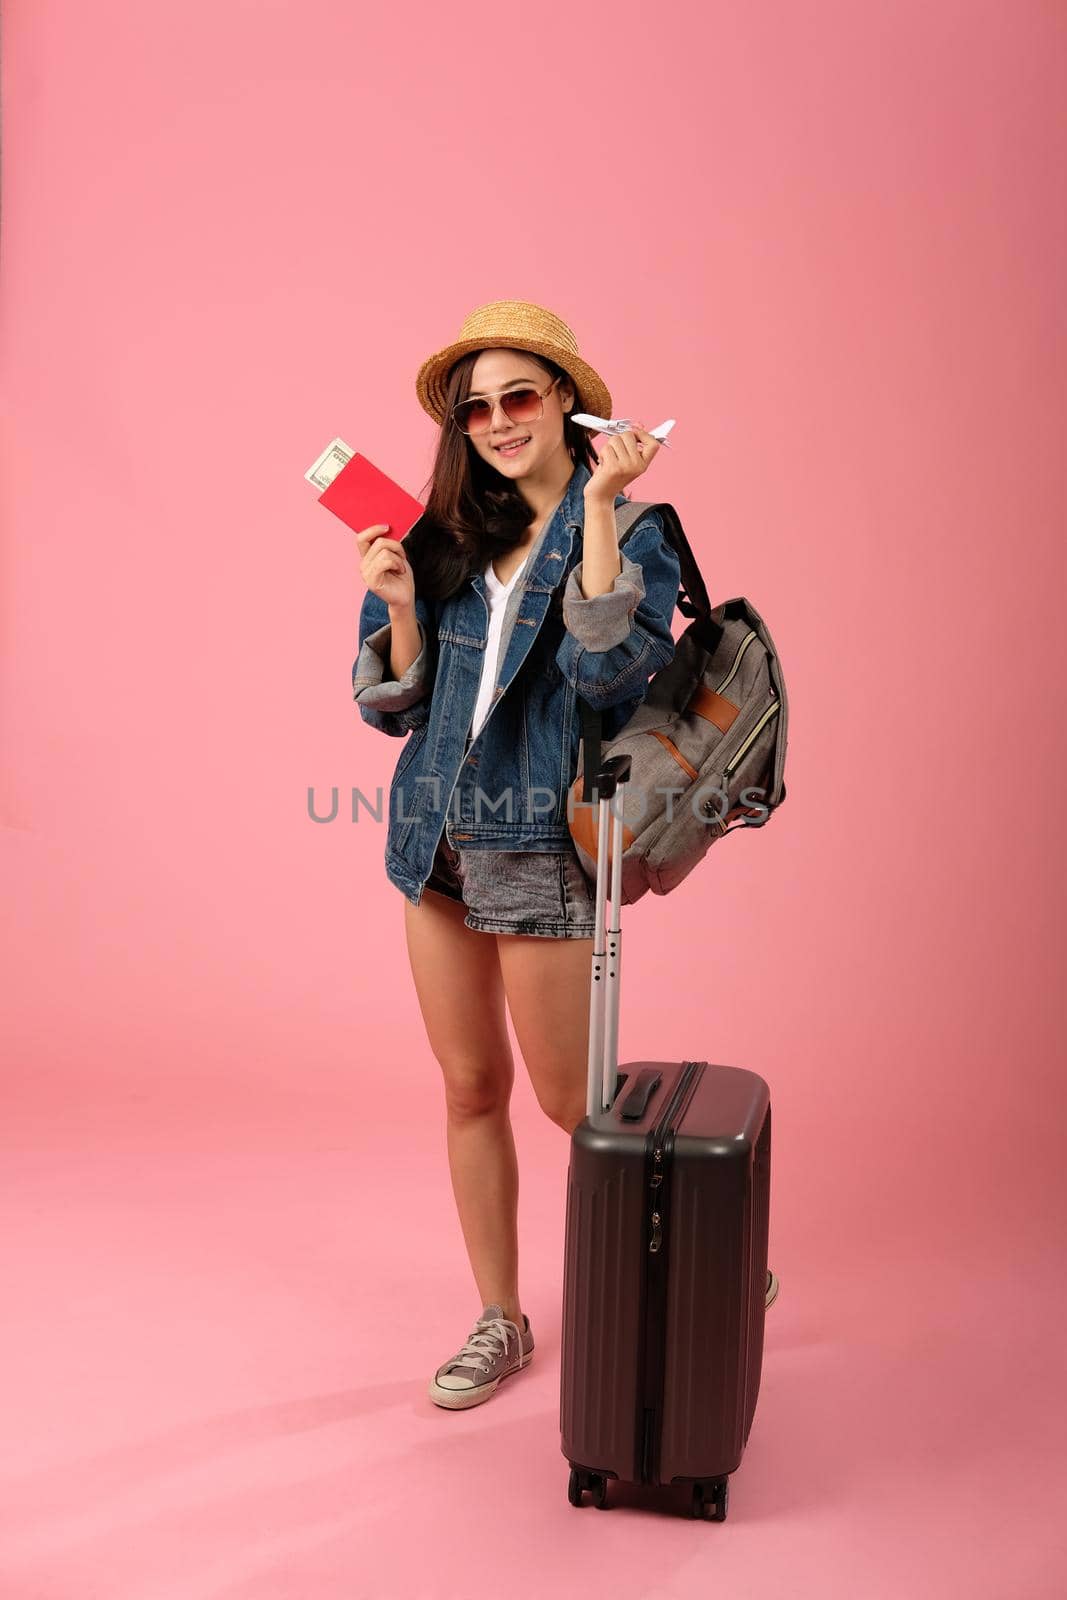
[{"xmin": 414, "ymin": 301, "xmax": 611, "ymax": 422}]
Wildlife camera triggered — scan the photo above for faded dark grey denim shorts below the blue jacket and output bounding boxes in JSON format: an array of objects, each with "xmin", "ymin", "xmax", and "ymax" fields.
[{"xmin": 426, "ymin": 834, "xmax": 597, "ymax": 939}]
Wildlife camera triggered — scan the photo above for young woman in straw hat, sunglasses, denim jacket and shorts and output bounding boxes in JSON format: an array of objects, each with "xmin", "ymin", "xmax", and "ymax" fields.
[{"xmin": 352, "ymin": 301, "xmax": 780, "ymax": 1410}]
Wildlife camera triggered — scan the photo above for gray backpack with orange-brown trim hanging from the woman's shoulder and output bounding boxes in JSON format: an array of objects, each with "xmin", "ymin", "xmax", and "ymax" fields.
[{"xmin": 568, "ymin": 501, "xmax": 789, "ymax": 906}]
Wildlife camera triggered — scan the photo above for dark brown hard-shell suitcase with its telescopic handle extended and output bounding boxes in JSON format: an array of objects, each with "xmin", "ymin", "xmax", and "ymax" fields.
[{"xmin": 560, "ymin": 755, "xmax": 771, "ymax": 1522}]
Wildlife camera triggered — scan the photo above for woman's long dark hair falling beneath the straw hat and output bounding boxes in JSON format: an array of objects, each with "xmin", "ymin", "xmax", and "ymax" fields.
[{"xmin": 403, "ymin": 350, "xmax": 598, "ymax": 600}]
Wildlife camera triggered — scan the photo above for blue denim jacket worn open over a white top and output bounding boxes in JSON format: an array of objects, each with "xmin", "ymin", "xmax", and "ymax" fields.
[{"xmin": 352, "ymin": 462, "xmax": 680, "ymax": 906}]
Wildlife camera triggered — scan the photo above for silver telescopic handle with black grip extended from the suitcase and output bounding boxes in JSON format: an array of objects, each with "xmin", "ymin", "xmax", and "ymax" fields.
[{"xmin": 585, "ymin": 755, "xmax": 630, "ymax": 1117}]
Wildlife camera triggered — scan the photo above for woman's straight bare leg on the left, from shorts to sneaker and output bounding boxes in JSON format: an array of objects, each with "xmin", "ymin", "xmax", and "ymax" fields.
[{"xmin": 405, "ymin": 890, "xmax": 523, "ymax": 1328}]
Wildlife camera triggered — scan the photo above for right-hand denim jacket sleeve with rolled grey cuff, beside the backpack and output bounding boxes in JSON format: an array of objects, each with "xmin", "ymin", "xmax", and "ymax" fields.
[{"xmin": 555, "ymin": 510, "xmax": 681, "ymax": 709}]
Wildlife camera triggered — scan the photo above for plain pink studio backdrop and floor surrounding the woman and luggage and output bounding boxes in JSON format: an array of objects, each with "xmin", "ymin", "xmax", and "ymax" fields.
[{"xmin": 0, "ymin": 0, "xmax": 1067, "ymax": 1600}]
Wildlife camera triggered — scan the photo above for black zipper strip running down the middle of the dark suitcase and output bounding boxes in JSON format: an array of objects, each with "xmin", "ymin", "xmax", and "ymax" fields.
[{"xmin": 637, "ymin": 1061, "xmax": 705, "ymax": 1483}]
